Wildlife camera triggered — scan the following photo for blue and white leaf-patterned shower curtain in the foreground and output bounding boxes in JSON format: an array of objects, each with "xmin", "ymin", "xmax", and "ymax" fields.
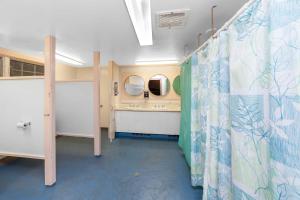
[{"xmin": 191, "ymin": 0, "xmax": 300, "ymax": 200}]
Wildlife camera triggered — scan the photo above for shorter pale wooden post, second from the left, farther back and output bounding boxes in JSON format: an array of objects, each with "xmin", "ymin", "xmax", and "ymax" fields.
[{"xmin": 94, "ymin": 51, "xmax": 101, "ymax": 156}]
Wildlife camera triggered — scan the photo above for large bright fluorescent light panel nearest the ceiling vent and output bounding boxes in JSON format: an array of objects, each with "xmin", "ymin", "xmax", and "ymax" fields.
[{"xmin": 125, "ymin": 0, "xmax": 153, "ymax": 46}]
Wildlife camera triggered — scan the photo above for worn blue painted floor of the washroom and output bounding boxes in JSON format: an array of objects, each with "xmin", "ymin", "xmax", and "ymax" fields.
[{"xmin": 0, "ymin": 130, "xmax": 202, "ymax": 200}]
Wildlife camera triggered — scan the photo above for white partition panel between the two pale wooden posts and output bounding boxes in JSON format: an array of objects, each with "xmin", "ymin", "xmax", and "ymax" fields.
[{"xmin": 55, "ymin": 81, "xmax": 94, "ymax": 137}]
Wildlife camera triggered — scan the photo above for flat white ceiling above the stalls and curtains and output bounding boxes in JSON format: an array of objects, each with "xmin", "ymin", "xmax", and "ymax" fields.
[{"xmin": 0, "ymin": 0, "xmax": 247, "ymax": 66}]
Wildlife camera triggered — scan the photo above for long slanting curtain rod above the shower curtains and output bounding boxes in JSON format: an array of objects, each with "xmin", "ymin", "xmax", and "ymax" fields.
[{"xmin": 180, "ymin": 0, "xmax": 257, "ymax": 64}]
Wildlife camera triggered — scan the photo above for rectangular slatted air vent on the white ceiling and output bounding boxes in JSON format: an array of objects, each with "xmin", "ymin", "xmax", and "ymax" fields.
[{"xmin": 157, "ymin": 9, "xmax": 189, "ymax": 28}]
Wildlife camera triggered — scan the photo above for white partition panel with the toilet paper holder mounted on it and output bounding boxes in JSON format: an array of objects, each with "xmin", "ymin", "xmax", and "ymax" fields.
[{"xmin": 0, "ymin": 79, "xmax": 45, "ymax": 158}]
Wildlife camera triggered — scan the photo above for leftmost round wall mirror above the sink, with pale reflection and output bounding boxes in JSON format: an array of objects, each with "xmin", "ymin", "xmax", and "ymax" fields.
[{"xmin": 124, "ymin": 75, "xmax": 145, "ymax": 96}]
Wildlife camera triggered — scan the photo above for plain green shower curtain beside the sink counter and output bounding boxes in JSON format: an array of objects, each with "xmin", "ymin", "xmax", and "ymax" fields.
[{"xmin": 179, "ymin": 59, "xmax": 191, "ymax": 166}]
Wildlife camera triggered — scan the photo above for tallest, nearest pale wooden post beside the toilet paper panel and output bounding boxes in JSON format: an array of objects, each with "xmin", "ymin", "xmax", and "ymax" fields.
[{"xmin": 44, "ymin": 36, "xmax": 56, "ymax": 186}]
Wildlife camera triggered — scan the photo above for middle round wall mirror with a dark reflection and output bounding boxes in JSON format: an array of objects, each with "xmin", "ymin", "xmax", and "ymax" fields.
[{"xmin": 148, "ymin": 75, "xmax": 170, "ymax": 96}]
